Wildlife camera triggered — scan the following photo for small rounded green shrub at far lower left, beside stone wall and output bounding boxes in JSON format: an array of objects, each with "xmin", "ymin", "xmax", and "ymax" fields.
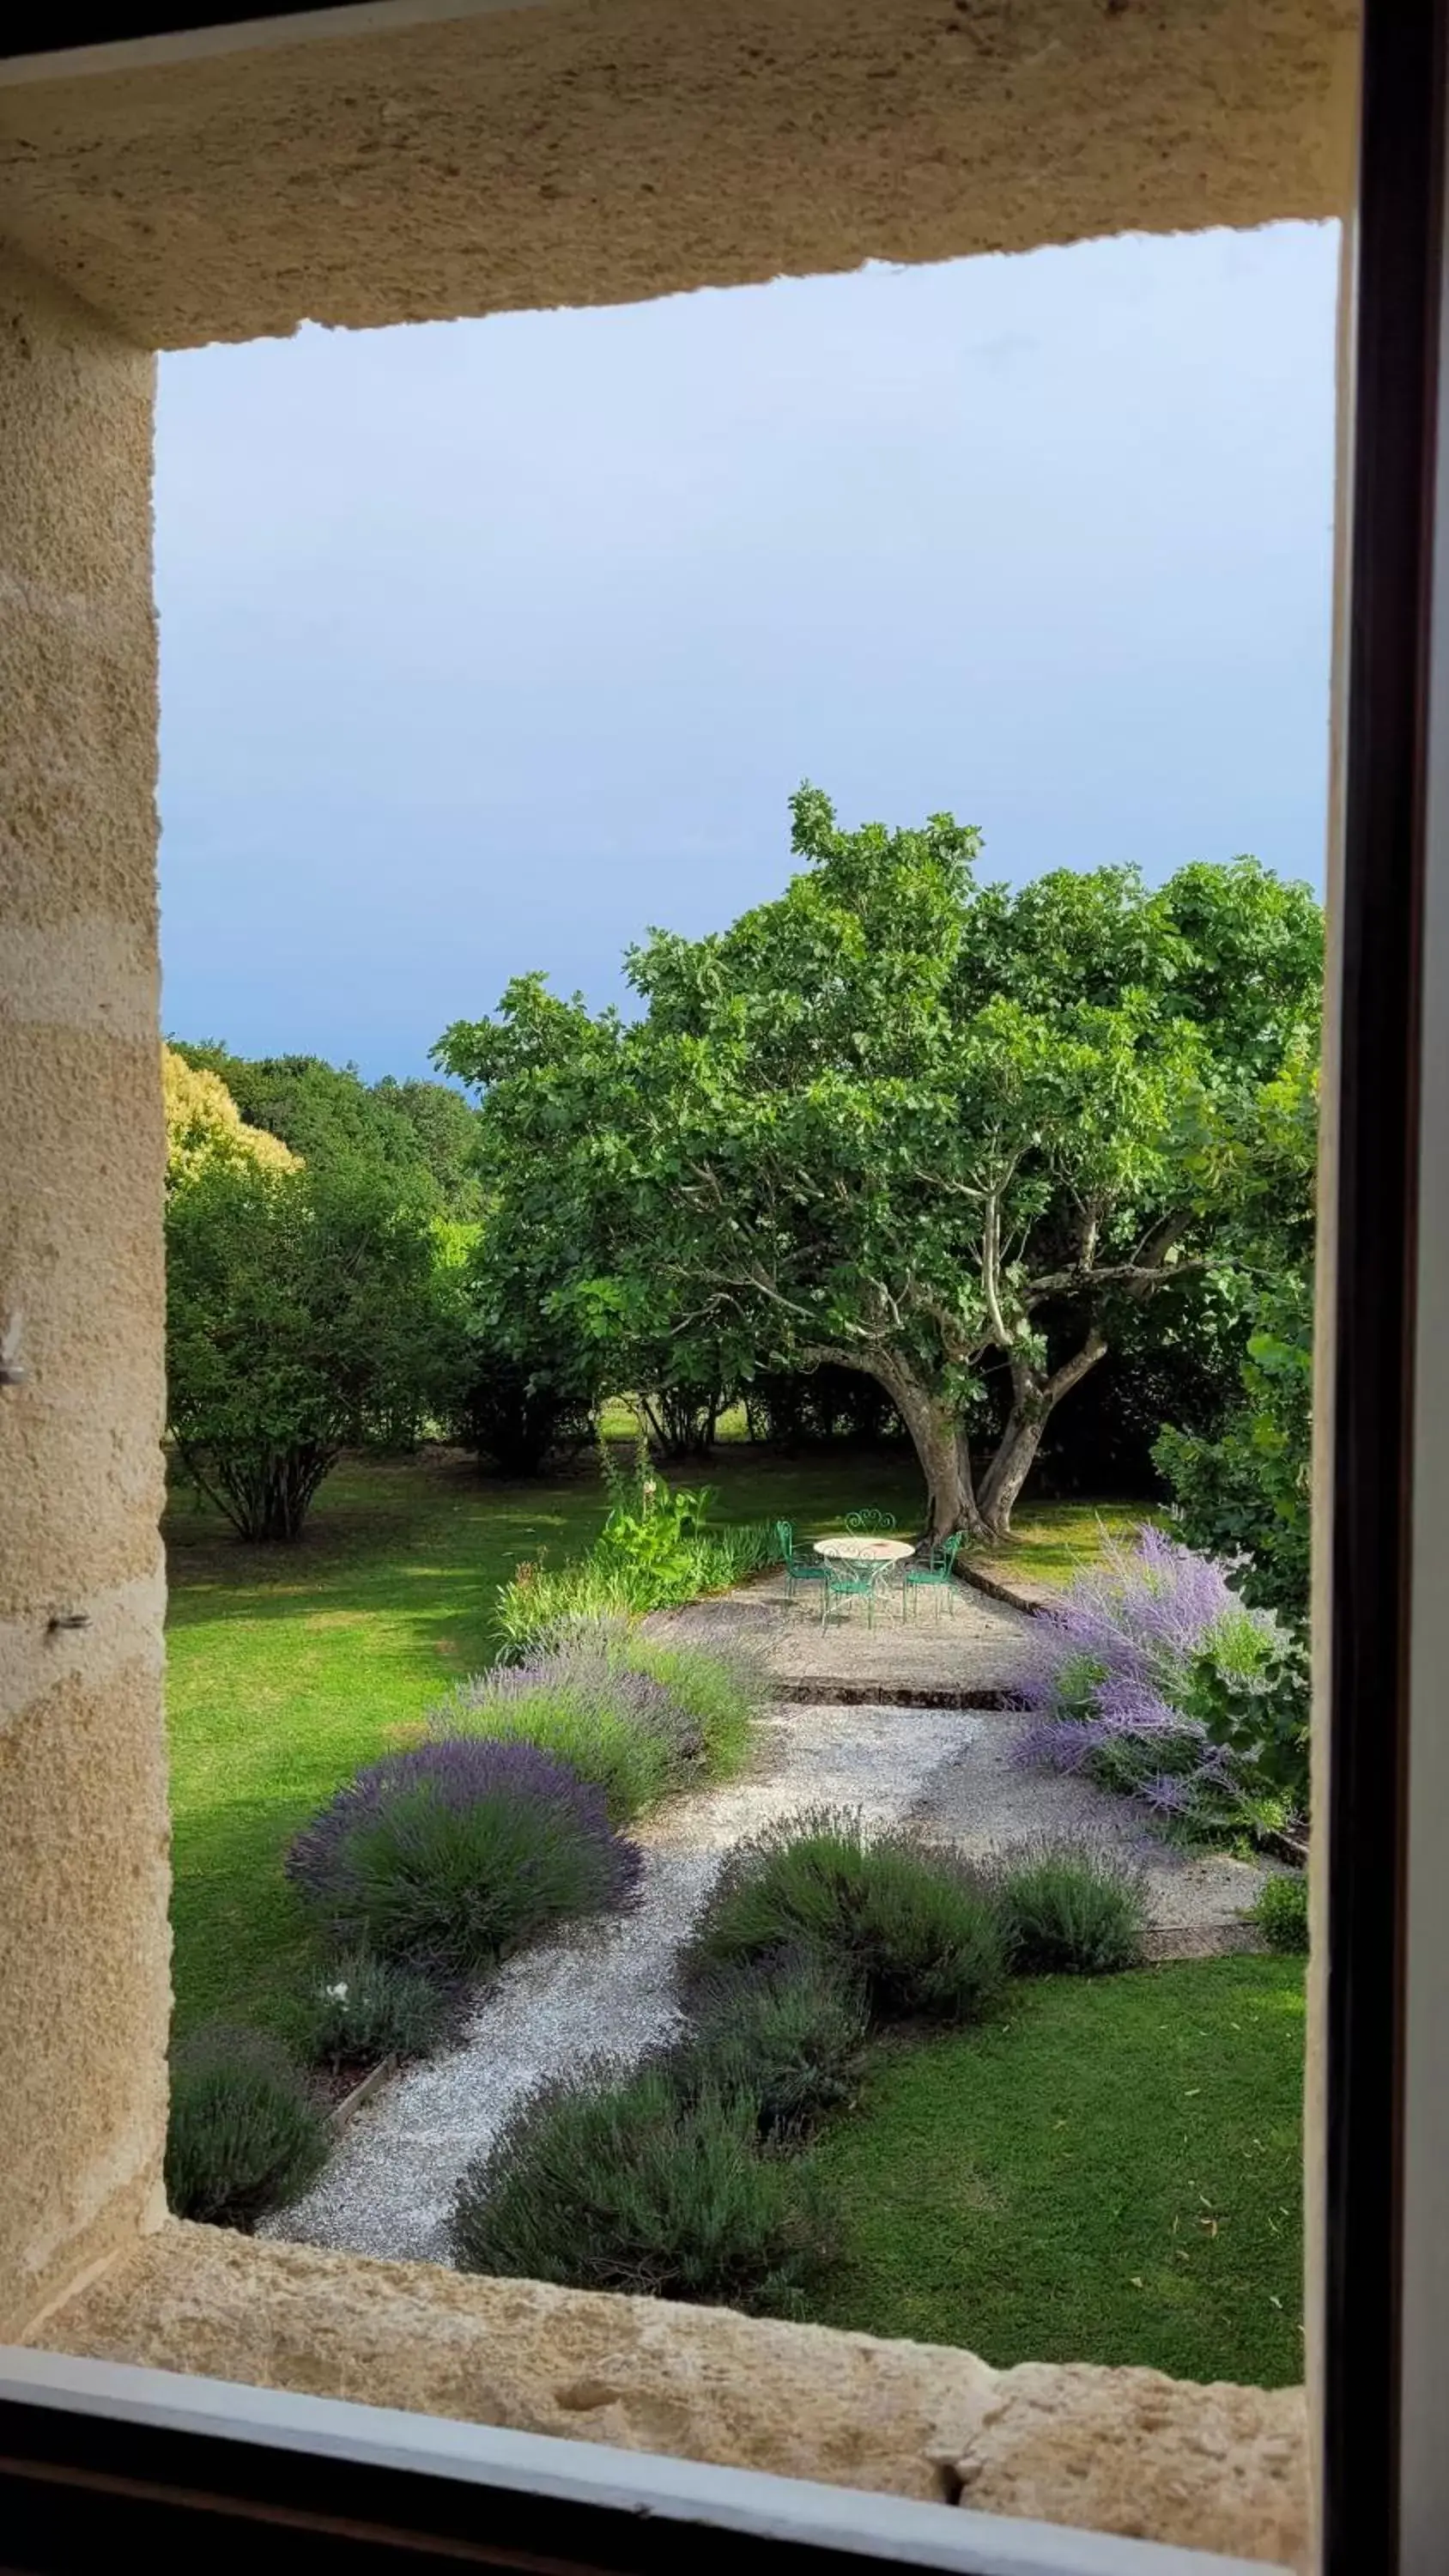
[{"xmin": 165, "ymin": 2025, "xmax": 327, "ymax": 2236}]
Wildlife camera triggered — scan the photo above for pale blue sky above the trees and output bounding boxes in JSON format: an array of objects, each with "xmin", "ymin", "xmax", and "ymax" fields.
[{"xmin": 157, "ymin": 224, "xmax": 1336, "ymax": 1074}]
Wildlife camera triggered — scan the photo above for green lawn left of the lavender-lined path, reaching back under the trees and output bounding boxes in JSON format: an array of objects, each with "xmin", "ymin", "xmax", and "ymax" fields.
[{"xmin": 167, "ymin": 1448, "xmax": 921, "ymax": 2025}]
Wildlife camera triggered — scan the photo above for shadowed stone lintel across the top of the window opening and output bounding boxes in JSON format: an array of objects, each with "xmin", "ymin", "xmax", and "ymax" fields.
[{"xmin": 0, "ymin": 0, "xmax": 1356, "ymax": 348}]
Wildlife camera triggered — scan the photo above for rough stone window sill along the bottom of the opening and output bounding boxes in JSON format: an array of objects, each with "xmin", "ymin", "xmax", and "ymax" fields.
[{"xmin": 39, "ymin": 2223, "xmax": 1307, "ymax": 2568}]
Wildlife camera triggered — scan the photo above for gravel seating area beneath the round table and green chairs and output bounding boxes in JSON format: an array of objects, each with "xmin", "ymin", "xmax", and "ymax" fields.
[{"xmin": 646, "ymin": 1569, "xmax": 1029, "ymax": 1708}]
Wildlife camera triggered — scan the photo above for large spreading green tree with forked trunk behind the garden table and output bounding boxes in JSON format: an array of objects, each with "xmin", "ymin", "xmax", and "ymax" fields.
[{"xmin": 435, "ymin": 788, "xmax": 1320, "ymax": 1535}]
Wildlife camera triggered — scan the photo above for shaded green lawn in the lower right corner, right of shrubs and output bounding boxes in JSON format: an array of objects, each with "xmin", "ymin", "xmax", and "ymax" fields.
[{"xmin": 810, "ymin": 1958, "xmax": 1302, "ymax": 2388}]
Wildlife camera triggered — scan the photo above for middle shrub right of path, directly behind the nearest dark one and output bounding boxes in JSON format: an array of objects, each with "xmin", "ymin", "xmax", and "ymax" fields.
[{"xmin": 664, "ymin": 1950, "xmax": 870, "ymax": 2146}]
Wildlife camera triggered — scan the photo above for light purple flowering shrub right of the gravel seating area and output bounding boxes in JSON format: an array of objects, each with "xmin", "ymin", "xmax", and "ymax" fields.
[{"xmin": 1014, "ymin": 1525, "xmax": 1294, "ymax": 1839}]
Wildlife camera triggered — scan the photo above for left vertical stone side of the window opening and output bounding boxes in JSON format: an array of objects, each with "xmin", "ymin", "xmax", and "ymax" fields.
[{"xmin": 0, "ymin": 263, "xmax": 167, "ymax": 2336}]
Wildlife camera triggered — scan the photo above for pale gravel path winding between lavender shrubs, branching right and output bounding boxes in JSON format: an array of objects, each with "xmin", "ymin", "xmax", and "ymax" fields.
[{"xmin": 265, "ymin": 1705, "xmax": 1264, "ymax": 2262}]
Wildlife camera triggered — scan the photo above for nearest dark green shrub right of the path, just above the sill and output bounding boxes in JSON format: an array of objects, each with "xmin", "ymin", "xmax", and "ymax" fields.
[{"xmin": 453, "ymin": 2066, "xmax": 831, "ymax": 2311}]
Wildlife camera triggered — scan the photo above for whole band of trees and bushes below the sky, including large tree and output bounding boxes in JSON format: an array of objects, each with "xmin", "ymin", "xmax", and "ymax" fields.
[{"xmin": 167, "ymin": 788, "xmax": 1323, "ymax": 1607}]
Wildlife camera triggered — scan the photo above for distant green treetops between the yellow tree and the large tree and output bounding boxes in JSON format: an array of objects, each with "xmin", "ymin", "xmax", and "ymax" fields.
[{"xmin": 173, "ymin": 1041, "xmax": 482, "ymax": 1218}]
